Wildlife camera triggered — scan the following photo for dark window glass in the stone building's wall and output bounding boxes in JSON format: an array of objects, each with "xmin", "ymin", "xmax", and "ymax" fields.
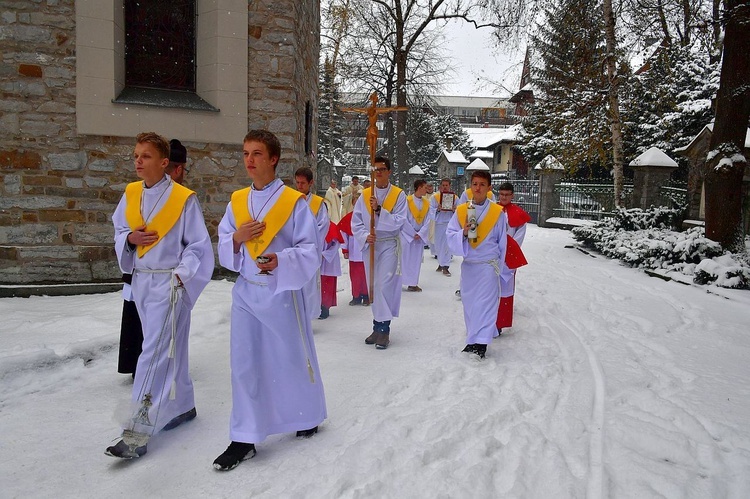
[{"xmin": 125, "ymin": 0, "xmax": 196, "ymax": 92}]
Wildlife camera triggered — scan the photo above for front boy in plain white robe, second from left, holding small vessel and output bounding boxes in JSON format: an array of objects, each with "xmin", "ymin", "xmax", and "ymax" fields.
[{"xmin": 213, "ymin": 130, "xmax": 326, "ymax": 471}]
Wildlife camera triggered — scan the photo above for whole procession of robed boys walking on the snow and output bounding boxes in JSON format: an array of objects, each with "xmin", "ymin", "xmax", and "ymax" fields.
[{"xmin": 105, "ymin": 130, "xmax": 528, "ymax": 471}]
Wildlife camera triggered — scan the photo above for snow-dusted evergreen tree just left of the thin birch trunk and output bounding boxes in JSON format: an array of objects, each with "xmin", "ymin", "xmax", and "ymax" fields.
[{"xmin": 519, "ymin": 0, "xmax": 611, "ymax": 175}]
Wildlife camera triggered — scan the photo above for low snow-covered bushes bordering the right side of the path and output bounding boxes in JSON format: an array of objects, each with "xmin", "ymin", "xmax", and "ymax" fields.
[{"xmin": 573, "ymin": 208, "xmax": 750, "ymax": 289}]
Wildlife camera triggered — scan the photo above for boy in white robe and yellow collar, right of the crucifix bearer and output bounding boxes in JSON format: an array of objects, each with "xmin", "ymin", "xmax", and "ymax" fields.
[{"xmin": 446, "ymin": 170, "xmax": 507, "ymax": 358}]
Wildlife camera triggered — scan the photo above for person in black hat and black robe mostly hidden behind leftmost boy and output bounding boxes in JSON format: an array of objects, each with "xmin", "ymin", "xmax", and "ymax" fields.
[{"xmin": 117, "ymin": 139, "xmax": 188, "ymax": 378}]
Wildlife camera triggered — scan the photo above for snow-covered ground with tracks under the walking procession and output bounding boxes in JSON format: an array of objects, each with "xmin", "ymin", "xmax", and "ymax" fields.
[{"xmin": 0, "ymin": 226, "xmax": 750, "ymax": 499}]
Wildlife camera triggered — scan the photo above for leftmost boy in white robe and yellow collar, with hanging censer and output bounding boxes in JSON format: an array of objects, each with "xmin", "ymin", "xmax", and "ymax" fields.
[{"xmin": 105, "ymin": 132, "xmax": 214, "ymax": 459}]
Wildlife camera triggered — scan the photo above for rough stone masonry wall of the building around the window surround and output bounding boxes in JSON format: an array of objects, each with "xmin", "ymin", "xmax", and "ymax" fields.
[{"xmin": 0, "ymin": 0, "xmax": 319, "ymax": 284}]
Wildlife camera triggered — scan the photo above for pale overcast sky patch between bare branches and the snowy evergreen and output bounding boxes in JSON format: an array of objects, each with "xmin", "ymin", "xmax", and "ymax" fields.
[{"xmin": 442, "ymin": 21, "xmax": 524, "ymax": 97}]
